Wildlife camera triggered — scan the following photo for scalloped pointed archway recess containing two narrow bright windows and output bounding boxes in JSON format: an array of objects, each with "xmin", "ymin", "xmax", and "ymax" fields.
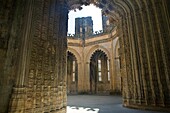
[{"xmin": 89, "ymin": 50, "xmax": 110, "ymax": 94}]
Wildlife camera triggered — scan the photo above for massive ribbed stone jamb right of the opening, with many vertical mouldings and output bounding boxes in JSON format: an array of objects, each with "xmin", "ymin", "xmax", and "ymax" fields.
[{"xmin": 121, "ymin": 0, "xmax": 170, "ymax": 111}]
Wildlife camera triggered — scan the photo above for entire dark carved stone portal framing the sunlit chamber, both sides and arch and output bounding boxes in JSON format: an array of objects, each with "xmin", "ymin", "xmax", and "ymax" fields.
[{"xmin": 0, "ymin": 0, "xmax": 170, "ymax": 113}]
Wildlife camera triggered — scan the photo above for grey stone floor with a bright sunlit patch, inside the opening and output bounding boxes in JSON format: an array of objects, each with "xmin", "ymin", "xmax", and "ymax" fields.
[{"xmin": 67, "ymin": 95, "xmax": 169, "ymax": 113}]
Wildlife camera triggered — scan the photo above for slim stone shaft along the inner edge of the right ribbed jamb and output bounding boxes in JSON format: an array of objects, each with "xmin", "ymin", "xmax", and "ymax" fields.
[{"xmin": 118, "ymin": 17, "xmax": 132, "ymax": 106}]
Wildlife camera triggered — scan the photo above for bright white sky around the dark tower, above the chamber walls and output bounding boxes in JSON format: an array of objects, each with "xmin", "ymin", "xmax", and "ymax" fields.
[{"xmin": 68, "ymin": 4, "xmax": 102, "ymax": 34}]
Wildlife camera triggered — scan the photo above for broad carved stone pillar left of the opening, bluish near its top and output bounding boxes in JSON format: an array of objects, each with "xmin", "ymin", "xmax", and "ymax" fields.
[{"xmin": 10, "ymin": 0, "xmax": 68, "ymax": 113}]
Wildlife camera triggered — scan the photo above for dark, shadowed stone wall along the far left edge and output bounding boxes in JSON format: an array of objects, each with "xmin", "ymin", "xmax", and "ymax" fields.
[{"xmin": 0, "ymin": 0, "xmax": 23, "ymax": 113}]
